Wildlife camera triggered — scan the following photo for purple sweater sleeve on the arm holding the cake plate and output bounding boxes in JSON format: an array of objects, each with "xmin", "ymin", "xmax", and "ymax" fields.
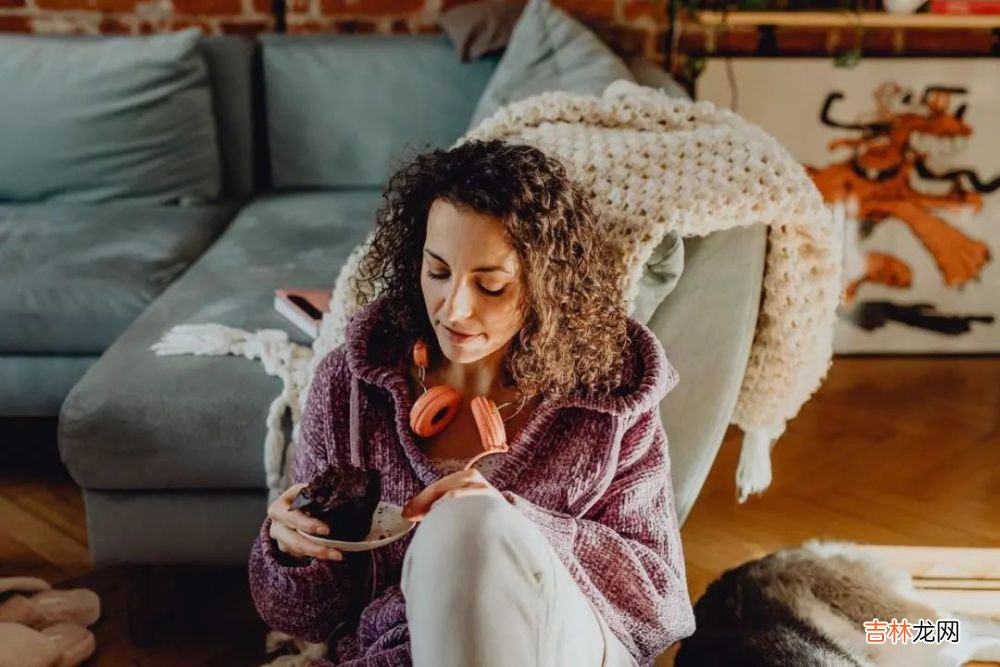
[{"xmin": 250, "ymin": 346, "xmax": 364, "ymax": 642}]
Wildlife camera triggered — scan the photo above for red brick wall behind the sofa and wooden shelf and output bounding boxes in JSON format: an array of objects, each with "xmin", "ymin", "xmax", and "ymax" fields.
[{"xmin": 0, "ymin": 0, "xmax": 997, "ymax": 66}]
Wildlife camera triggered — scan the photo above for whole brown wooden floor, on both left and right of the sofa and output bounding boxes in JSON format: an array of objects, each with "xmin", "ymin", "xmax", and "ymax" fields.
[{"xmin": 0, "ymin": 357, "xmax": 1000, "ymax": 667}]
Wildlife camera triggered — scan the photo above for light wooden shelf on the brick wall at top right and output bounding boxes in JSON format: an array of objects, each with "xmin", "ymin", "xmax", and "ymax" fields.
[{"xmin": 695, "ymin": 11, "xmax": 1000, "ymax": 30}]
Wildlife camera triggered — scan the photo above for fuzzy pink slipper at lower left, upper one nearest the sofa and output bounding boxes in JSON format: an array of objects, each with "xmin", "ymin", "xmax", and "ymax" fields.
[{"xmin": 0, "ymin": 577, "xmax": 101, "ymax": 628}]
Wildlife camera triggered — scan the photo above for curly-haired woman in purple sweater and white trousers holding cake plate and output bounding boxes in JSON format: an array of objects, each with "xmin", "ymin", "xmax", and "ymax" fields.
[{"xmin": 250, "ymin": 141, "xmax": 694, "ymax": 667}]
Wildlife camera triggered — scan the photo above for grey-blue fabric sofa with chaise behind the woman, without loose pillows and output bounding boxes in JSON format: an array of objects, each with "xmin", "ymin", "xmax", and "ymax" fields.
[{"xmin": 0, "ymin": 36, "xmax": 766, "ymax": 576}]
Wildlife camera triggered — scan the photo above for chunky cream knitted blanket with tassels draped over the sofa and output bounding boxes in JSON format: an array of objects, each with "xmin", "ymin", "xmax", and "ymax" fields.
[{"xmin": 153, "ymin": 81, "xmax": 843, "ymax": 501}]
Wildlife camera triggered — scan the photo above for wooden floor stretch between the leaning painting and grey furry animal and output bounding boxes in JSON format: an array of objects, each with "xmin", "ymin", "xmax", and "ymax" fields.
[{"xmin": 683, "ymin": 358, "xmax": 1000, "ymax": 596}]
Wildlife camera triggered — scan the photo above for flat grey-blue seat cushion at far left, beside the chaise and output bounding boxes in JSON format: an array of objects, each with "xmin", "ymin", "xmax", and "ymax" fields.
[{"xmin": 0, "ymin": 204, "xmax": 233, "ymax": 355}]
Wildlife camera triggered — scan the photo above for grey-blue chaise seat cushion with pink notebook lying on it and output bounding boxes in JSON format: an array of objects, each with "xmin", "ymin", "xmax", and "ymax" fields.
[{"xmin": 59, "ymin": 190, "xmax": 382, "ymax": 490}]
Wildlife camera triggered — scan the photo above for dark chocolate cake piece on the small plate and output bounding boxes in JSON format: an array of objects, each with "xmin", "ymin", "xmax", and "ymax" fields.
[{"xmin": 292, "ymin": 466, "xmax": 382, "ymax": 542}]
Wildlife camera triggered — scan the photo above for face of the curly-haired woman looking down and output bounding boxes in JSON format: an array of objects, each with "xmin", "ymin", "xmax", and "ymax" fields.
[{"xmin": 420, "ymin": 199, "xmax": 521, "ymax": 363}]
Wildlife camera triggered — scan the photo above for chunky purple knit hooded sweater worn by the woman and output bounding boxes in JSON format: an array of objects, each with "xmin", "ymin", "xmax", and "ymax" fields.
[{"xmin": 250, "ymin": 301, "xmax": 694, "ymax": 667}]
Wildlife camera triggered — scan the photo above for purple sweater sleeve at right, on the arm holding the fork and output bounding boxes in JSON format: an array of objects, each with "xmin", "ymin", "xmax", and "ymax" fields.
[{"xmin": 503, "ymin": 407, "xmax": 694, "ymax": 665}]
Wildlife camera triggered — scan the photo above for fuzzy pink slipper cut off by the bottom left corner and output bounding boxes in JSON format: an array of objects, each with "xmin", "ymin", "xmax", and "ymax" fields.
[{"xmin": 0, "ymin": 623, "xmax": 97, "ymax": 667}]
